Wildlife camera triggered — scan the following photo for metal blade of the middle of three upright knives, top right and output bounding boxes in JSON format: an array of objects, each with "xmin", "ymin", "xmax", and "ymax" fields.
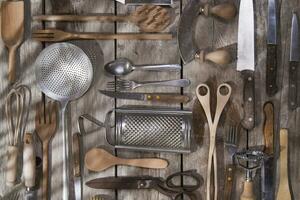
[{"xmin": 267, "ymin": 0, "xmax": 277, "ymax": 44}]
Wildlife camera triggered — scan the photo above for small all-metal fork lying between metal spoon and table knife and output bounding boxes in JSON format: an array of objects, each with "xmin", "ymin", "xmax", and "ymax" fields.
[{"xmin": 106, "ymin": 79, "xmax": 191, "ymax": 90}]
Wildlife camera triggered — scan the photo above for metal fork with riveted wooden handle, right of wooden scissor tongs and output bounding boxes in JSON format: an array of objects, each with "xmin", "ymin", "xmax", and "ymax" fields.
[{"xmin": 224, "ymin": 125, "xmax": 240, "ymax": 200}]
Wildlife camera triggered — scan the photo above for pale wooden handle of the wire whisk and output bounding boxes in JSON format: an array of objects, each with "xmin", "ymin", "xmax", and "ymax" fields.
[{"xmin": 6, "ymin": 145, "xmax": 18, "ymax": 186}]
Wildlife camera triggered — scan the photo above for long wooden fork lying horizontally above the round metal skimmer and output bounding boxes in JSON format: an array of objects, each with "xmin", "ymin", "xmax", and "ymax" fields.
[{"xmin": 32, "ymin": 29, "xmax": 173, "ymax": 42}]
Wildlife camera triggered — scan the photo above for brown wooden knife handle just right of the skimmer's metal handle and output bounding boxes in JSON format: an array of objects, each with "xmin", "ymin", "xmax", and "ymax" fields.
[{"xmin": 72, "ymin": 133, "xmax": 81, "ymax": 177}]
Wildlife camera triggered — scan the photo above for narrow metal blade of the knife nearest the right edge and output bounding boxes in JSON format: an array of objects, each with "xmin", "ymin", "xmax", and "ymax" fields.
[{"xmin": 290, "ymin": 13, "xmax": 300, "ymax": 62}]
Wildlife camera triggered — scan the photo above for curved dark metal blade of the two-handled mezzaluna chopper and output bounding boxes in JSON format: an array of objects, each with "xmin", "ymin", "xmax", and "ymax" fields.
[{"xmin": 177, "ymin": 0, "xmax": 201, "ymax": 63}]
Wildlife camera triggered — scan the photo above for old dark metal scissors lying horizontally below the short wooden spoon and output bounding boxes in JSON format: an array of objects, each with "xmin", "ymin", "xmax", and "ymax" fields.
[{"xmin": 85, "ymin": 170, "xmax": 203, "ymax": 200}]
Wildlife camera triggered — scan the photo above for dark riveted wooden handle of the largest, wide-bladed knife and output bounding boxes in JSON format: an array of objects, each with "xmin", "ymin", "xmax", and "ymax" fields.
[{"xmin": 242, "ymin": 70, "xmax": 255, "ymax": 130}]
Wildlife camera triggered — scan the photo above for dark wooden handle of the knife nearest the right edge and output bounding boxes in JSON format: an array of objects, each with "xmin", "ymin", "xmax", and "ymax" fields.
[{"xmin": 288, "ymin": 61, "xmax": 298, "ymax": 110}]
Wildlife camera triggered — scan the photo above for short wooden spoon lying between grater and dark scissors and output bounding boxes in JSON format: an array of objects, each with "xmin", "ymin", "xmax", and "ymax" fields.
[{"xmin": 85, "ymin": 148, "xmax": 168, "ymax": 172}]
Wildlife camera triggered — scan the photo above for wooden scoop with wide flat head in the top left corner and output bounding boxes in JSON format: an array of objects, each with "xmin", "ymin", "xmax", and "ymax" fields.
[{"xmin": 1, "ymin": 1, "xmax": 24, "ymax": 83}]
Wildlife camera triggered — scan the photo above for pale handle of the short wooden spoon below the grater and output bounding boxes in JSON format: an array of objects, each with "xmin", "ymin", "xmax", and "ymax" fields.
[{"xmin": 117, "ymin": 158, "xmax": 168, "ymax": 169}]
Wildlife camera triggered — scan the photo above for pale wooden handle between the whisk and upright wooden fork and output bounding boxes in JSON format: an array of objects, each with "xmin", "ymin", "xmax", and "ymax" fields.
[{"xmin": 23, "ymin": 133, "xmax": 36, "ymax": 188}]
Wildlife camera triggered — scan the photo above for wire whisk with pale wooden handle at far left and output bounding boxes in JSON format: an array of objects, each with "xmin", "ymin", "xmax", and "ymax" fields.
[{"xmin": 5, "ymin": 85, "xmax": 31, "ymax": 186}]
